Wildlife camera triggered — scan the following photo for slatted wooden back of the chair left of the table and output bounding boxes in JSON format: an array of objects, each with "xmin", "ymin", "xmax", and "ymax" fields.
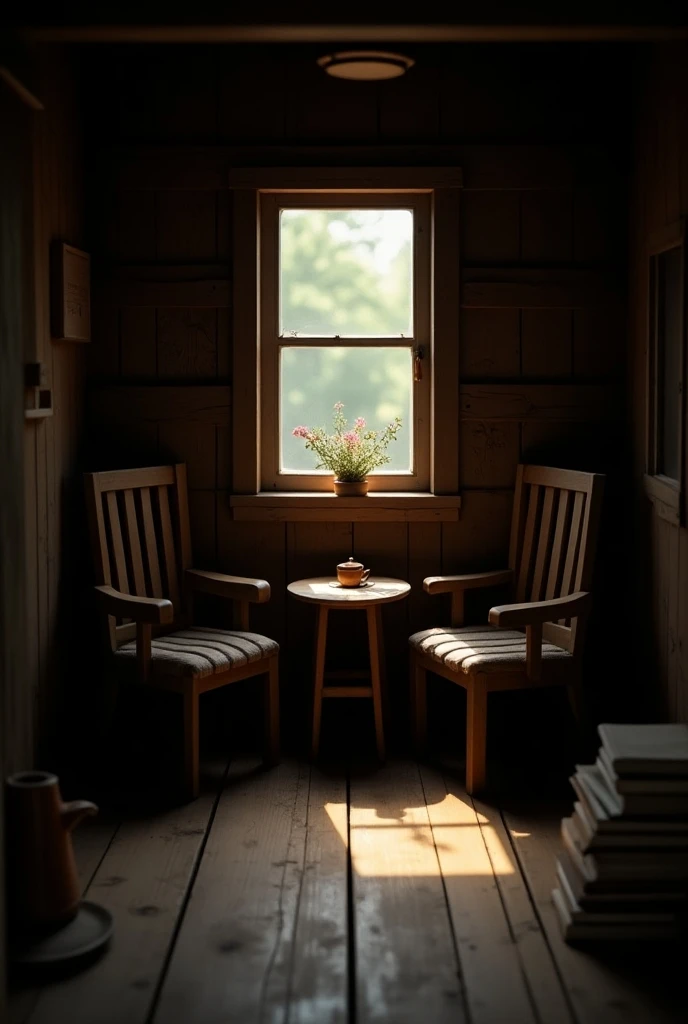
[{"xmin": 85, "ymin": 464, "xmax": 191, "ymax": 650}]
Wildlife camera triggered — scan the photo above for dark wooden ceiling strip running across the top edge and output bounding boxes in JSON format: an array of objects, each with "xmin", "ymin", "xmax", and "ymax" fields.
[{"xmin": 14, "ymin": 0, "xmax": 688, "ymax": 43}]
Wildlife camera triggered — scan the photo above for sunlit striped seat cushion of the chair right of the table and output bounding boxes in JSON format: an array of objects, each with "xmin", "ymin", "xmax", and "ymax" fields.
[{"xmin": 409, "ymin": 626, "xmax": 571, "ymax": 675}]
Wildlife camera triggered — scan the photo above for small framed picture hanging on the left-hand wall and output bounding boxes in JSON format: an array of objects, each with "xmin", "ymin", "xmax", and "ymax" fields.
[{"xmin": 51, "ymin": 242, "xmax": 91, "ymax": 341}]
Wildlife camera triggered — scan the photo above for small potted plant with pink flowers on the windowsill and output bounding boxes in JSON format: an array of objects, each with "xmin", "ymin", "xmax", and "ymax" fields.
[{"xmin": 292, "ymin": 401, "xmax": 401, "ymax": 498}]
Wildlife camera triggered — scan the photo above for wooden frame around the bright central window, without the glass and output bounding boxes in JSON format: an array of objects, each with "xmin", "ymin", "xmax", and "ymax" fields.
[{"xmin": 229, "ymin": 167, "xmax": 462, "ymax": 520}]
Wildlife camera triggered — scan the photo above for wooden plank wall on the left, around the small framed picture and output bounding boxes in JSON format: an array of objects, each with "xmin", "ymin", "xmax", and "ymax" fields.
[{"xmin": 25, "ymin": 47, "xmax": 86, "ymax": 764}]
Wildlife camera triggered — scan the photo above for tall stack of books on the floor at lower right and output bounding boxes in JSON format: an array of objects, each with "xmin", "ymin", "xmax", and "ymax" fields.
[{"xmin": 552, "ymin": 725, "xmax": 688, "ymax": 941}]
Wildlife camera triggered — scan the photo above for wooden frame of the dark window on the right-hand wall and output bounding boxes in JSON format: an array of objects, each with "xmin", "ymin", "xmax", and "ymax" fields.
[{"xmin": 644, "ymin": 218, "xmax": 687, "ymax": 525}]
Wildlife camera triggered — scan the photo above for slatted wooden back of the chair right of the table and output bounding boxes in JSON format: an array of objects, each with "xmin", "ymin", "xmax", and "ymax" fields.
[{"xmin": 509, "ymin": 466, "xmax": 604, "ymax": 653}]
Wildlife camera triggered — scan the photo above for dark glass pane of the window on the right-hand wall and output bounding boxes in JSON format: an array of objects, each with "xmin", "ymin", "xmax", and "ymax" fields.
[{"xmin": 656, "ymin": 248, "xmax": 682, "ymax": 480}]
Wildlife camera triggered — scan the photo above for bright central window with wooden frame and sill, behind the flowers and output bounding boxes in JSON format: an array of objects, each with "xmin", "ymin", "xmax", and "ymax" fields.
[{"xmin": 229, "ymin": 169, "xmax": 461, "ymax": 522}]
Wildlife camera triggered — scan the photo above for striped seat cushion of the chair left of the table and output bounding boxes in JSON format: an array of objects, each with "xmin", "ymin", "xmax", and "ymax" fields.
[{"xmin": 115, "ymin": 626, "xmax": 280, "ymax": 677}]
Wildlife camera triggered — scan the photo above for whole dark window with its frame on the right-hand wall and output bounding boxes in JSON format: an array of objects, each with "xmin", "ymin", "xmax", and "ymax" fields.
[{"xmin": 646, "ymin": 224, "xmax": 685, "ymax": 521}]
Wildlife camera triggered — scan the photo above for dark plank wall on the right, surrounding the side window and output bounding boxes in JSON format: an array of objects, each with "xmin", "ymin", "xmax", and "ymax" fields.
[{"xmin": 630, "ymin": 44, "xmax": 688, "ymax": 722}]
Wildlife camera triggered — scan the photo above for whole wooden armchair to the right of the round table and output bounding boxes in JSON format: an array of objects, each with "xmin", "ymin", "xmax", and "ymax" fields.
[{"xmin": 410, "ymin": 466, "xmax": 604, "ymax": 793}]
